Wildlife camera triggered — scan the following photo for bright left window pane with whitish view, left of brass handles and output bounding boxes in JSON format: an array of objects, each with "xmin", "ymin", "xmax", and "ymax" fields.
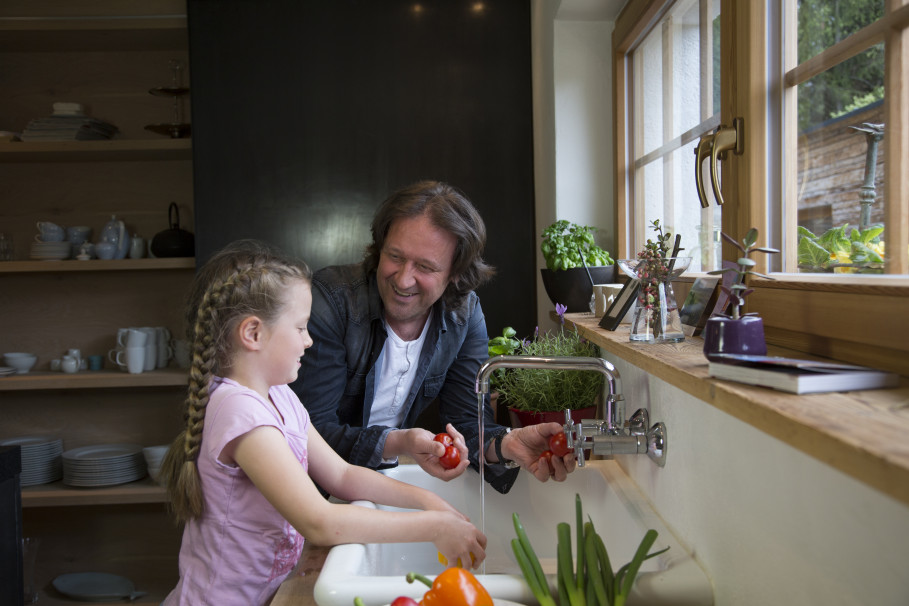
[{"xmin": 632, "ymin": 0, "xmax": 721, "ymax": 272}]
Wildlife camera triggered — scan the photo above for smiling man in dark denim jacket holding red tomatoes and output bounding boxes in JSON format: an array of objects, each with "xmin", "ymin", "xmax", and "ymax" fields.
[{"xmin": 291, "ymin": 181, "xmax": 576, "ymax": 492}]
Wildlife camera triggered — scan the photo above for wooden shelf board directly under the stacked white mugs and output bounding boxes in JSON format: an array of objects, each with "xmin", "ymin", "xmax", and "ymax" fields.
[{"xmin": 0, "ymin": 368, "xmax": 189, "ymax": 392}]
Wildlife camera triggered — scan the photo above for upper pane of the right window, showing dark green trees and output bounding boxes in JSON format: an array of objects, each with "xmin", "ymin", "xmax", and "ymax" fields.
[{"xmin": 798, "ymin": 0, "xmax": 884, "ymax": 63}]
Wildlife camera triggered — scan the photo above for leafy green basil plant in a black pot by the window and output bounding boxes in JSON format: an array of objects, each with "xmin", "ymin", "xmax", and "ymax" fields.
[{"xmin": 540, "ymin": 219, "xmax": 615, "ymax": 312}]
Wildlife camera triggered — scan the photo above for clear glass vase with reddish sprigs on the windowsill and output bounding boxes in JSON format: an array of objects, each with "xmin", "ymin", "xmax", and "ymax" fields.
[{"xmin": 618, "ymin": 257, "xmax": 691, "ymax": 343}]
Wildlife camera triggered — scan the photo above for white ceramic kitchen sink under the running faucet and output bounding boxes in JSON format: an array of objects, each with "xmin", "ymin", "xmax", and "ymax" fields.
[{"xmin": 314, "ymin": 461, "xmax": 713, "ymax": 606}]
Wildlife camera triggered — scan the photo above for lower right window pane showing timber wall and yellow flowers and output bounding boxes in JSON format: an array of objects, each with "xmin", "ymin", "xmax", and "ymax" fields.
[{"xmin": 797, "ymin": 44, "xmax": 886, "ymax": 273}]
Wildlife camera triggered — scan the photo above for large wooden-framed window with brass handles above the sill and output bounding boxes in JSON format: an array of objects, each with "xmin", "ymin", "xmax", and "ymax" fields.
[{"xmin": 613, "ymin": 0, "xmax": 909, "ymax": 375}]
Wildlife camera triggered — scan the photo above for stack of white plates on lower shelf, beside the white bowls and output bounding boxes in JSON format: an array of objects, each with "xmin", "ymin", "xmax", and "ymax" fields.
[{"xmin": 63, "ymin": 444, "xmax": 148, "ymax": 487}]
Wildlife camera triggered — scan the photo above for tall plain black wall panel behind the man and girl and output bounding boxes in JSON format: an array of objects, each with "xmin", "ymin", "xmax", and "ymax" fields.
[{"xmin": 188, "ymin": 0, "xmax": 537, "ymax": 334}]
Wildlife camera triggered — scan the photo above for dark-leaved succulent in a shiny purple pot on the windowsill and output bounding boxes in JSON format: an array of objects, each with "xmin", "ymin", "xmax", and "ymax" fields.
[{"xmin": 704, "ymin": 227, "xmax": 780, "ymax": 360}]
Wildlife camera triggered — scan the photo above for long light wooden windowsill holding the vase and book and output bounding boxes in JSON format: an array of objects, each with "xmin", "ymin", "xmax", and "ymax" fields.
[{"xmin": 565, "ymin": 313, "xmax": 909, "ymax": 505}]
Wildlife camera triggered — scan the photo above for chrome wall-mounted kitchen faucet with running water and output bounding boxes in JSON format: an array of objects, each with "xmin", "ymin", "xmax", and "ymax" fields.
[{"xmin": 476, "ymin": 356, "xmax": 666, "ymax": 467}]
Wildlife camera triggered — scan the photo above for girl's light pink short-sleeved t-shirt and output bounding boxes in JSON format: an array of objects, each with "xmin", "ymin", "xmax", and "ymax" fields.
[{"xmin": 164, "ymin": 378, "xmax": 309, "ymax": 606}]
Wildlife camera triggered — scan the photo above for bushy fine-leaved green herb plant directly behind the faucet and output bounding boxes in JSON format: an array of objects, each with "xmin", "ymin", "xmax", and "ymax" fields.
[{"xmin": 489, "ymin": 304, "xmax": 603, "ymax": 427}]
